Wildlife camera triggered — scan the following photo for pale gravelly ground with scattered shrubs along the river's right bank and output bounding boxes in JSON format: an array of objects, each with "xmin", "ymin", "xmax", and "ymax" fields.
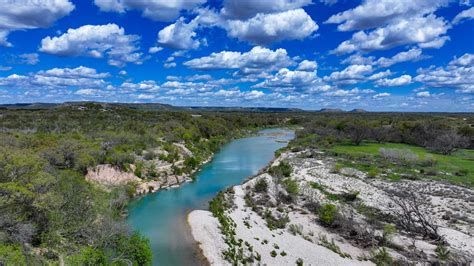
[{"xmin": 188, "ymin": 152, "xmax": 474, "ymax": 265}]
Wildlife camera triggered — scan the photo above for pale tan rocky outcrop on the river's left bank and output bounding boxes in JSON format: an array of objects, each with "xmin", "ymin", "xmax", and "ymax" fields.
[{"xmin": 86, "ymin": 143, "xmax": 209, "ymax": 195}]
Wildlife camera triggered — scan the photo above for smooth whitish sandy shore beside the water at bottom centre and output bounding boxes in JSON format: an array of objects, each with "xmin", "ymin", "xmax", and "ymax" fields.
[{"xmin": 188, "ymin": 186, "xmax": 373, "ymax": 265}]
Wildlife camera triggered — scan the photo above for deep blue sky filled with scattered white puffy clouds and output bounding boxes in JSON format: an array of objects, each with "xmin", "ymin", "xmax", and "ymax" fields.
[{"xmin": 0, "ymin": 0, "xmax": 474, "ymax": 112}]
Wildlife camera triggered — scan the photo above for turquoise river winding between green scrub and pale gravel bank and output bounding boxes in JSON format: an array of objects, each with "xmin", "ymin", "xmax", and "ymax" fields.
[{"xmin": 127, "ymin": 129, "xmax": 294, "ymax": 265}]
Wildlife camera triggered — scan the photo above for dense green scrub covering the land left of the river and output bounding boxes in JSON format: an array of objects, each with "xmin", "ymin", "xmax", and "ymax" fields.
[{"xmin": 0, "ymin": 104, "xmax": 283, "ymax": 265}]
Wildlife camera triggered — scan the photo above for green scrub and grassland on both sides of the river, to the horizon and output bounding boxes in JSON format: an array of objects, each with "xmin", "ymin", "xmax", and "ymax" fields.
[{"xmin": 0, "ymin": 103, "xmax": 474, "ymax": 265}]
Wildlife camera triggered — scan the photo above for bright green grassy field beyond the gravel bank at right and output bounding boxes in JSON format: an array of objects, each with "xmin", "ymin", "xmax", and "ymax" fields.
[{"xmin": 330, "ymin": 143, "xmax": 474, "ymax": 187}]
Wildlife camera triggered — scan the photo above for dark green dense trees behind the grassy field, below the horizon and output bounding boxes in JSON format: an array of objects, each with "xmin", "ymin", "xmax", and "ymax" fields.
[{"xmin": 296, "ymin": 113, "xmax": 474, "ymax": 154}]
